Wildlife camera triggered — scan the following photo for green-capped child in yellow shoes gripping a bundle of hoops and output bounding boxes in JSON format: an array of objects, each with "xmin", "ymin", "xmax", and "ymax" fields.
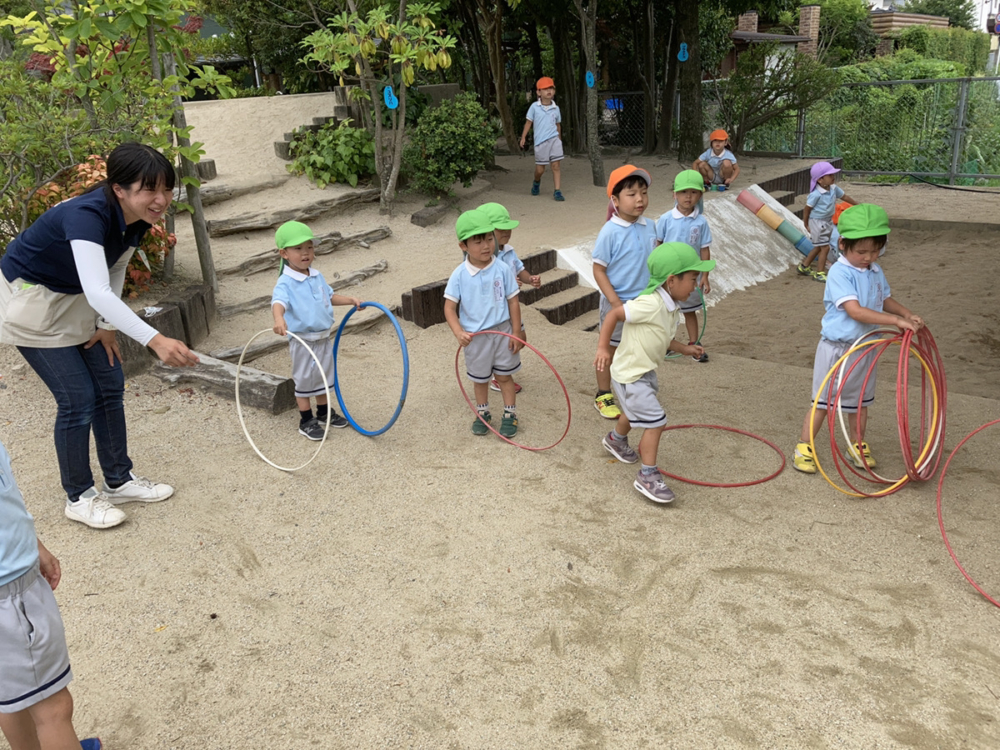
[{"xmin": 792, "ymin": 203, "xmax": 924, "ymax": 474}]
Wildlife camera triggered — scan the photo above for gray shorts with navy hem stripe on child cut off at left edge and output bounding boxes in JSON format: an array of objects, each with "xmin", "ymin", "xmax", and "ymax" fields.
[{"xmin": 0, "ymin": 563, "xmax": 73, "ymax": 714}]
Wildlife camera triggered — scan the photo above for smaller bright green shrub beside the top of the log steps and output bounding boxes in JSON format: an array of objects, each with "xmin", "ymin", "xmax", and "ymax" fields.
[{"xmin": 288, "ymin": 122, "xmax": 375, "ymax": 188}]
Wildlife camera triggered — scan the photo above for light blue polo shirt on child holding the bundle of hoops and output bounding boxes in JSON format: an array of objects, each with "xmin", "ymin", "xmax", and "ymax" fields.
[{"xmin": 821, "ymin": 255, "xmax": 890, "ymax": 342}]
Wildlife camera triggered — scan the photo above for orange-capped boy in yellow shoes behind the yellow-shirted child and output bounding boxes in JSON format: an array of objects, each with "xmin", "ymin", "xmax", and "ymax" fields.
[{"xmin": 591, "ymin": 164, "xmax": 657, "ymax": 419}]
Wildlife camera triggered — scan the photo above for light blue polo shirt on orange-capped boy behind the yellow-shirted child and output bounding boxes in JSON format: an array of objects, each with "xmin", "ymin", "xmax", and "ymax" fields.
[{"xmin": 591, "ymin": 214, "xmax": 657, "ymax": 302}]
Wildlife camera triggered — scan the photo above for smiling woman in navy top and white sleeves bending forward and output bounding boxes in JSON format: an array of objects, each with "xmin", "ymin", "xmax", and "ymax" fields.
[{"xmin": 0, "ymin": 143, "xmax": 198, "ymax": 529}]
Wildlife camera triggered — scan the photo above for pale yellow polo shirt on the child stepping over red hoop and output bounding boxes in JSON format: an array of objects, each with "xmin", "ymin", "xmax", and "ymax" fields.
[{"xmin": 611, "ymin": 287, "xmax": 681, "ymax": 383}]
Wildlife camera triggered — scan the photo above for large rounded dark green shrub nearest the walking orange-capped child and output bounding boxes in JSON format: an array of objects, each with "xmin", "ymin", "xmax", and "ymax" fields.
[{"xmin": 403, "ymin": 92, "xmax": 498, "ymax": 195}]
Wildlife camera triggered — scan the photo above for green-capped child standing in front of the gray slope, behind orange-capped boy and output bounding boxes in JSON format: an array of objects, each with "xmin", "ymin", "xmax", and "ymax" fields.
[{"xmin": 656, "ymin": 169, "xmax": 712, "ymax": 362}]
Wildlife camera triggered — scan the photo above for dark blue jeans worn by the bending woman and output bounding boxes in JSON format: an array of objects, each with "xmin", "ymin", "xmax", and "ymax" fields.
[{"xmin": 17, "ymin": 343, "xmax": 132, "ymax": 502}]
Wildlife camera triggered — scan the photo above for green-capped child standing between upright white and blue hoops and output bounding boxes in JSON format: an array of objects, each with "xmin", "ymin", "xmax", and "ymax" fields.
[{"xmin": 271, "ymin": 221, "xmax": 361, "ymax": 440}]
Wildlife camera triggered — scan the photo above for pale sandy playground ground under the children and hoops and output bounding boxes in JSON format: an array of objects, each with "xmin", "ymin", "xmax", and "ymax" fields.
[{"xmin": 0, "ymin": 98, "xmax": 1000, "ymax": 750}]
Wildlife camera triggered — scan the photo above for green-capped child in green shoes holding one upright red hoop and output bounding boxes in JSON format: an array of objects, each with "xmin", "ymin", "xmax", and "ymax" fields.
[{"xmin": 444, "ymin": 209, "xmax": 522, "ymax": 438}]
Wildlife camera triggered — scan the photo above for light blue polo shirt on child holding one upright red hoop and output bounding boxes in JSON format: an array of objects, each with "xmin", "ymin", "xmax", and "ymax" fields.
[{"xmin": 444, "ymin": 258, "xmax": 518, "ymax": 333}]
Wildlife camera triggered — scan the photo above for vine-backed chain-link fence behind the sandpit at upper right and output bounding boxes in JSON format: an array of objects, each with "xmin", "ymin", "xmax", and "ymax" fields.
[{"xmin": 744, "ymin": 77, "xmax": 1000, "ymax": 184}]
